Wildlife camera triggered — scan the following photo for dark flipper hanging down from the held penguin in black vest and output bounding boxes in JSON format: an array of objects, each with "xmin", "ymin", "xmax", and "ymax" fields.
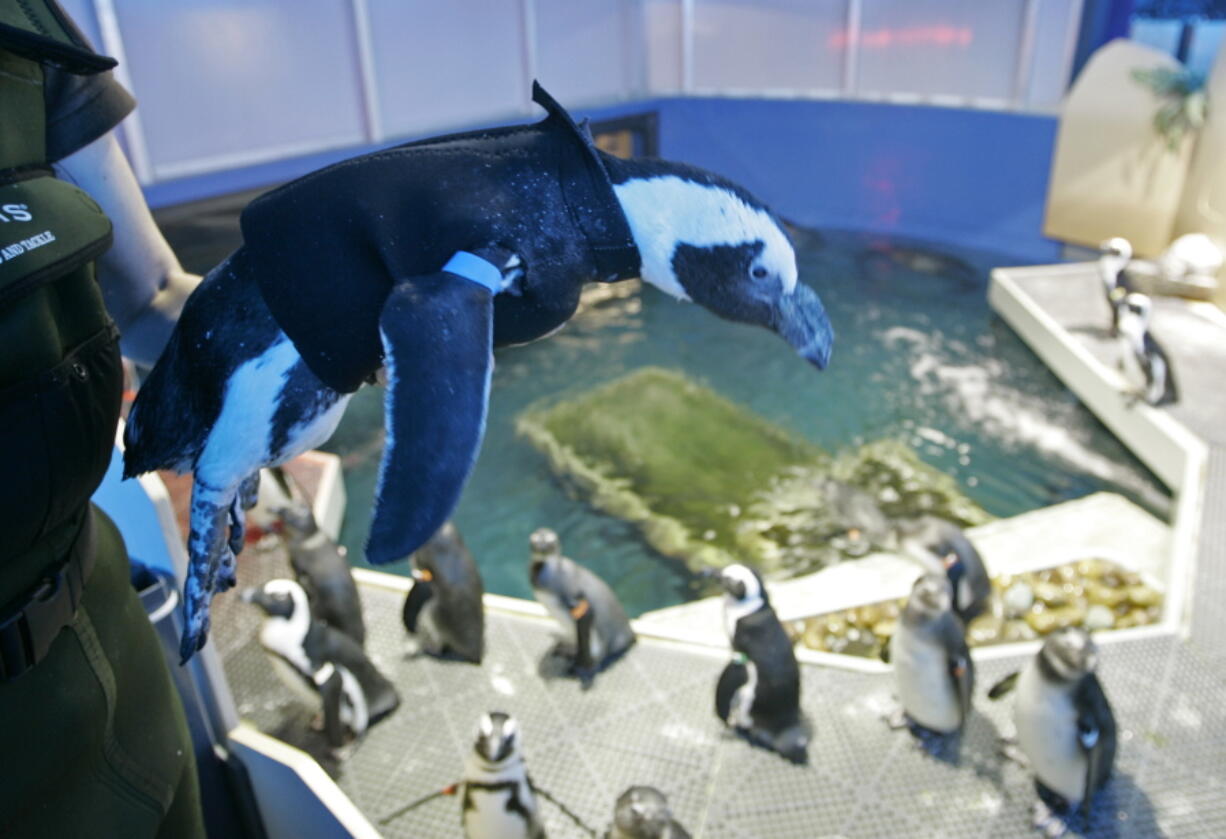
[{"xmin": 367, "ymin": 266, "xmax": 494, "ymax": 564}]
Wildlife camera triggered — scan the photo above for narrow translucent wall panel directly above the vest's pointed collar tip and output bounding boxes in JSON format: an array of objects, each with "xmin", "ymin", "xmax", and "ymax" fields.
[{"xmin": 528, "ymin": 0, "xmax": 642, "ymax": 105}]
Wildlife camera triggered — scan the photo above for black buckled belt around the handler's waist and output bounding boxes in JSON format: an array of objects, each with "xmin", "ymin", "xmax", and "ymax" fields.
[{"xmin": 0, "ymin": 511, "xmax": 94, "ymax": 683}]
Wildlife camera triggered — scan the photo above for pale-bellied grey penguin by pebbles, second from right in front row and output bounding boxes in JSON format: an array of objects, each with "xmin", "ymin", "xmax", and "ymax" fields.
[{"xmin": 890, "ymin": 574, "xmax": 975, "ymax": 735}]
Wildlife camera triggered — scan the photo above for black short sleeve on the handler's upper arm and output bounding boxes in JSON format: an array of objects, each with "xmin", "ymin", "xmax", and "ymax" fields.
[{"xmin": 43, "ymin": 4, "xmax": 136, "ymax": 163}]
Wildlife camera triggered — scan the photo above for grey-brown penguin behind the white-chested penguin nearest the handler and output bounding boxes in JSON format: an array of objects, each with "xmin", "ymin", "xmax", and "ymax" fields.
[{"xmin": 276, "ymin": 503, "xmax": 367, "ymax": 644}]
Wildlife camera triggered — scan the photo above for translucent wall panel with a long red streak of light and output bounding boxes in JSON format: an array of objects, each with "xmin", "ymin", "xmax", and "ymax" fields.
[{"xmin": 857, "ymin": 0, "xmax": 1024, "ymax": 101}]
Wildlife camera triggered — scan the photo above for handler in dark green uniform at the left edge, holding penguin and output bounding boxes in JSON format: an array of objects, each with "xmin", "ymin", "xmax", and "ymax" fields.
[{"xmin": 0, "ymin": 0, "xmax": 205, "ymax": 838}]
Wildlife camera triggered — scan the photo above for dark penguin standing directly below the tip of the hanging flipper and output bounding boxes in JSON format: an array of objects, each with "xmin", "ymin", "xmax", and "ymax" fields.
[{"xmin": 401, "ymin": 521, "xmax": 485, "ymax": 664}]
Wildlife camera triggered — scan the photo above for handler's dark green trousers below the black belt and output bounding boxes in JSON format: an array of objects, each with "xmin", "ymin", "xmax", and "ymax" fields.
[{"xmin": 0, "ymin": 508, "xmax": 205, "ymax": 839}]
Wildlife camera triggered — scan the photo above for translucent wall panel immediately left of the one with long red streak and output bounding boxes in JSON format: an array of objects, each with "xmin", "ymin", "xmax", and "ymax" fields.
[{"xmin": 694, "ymin": 0, "xmax": 853, "ymax": 91}]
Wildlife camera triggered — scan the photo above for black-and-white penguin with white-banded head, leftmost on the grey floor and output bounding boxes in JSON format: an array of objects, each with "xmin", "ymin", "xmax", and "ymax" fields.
[{"xmin": 243, "ymin": 579, "xmax": 400, "ymax": 748}]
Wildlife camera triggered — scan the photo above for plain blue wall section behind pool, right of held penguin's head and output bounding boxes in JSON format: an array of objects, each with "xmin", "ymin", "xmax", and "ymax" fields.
[{"xmin": 658, "ymin": 98, "xmax": 1059, "ymax": 261}]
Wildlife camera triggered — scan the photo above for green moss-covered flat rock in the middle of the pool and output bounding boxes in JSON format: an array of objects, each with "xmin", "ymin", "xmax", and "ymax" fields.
[{"xmin": 517, "ymin": 367, "xmax": 988, "ymax": 578}]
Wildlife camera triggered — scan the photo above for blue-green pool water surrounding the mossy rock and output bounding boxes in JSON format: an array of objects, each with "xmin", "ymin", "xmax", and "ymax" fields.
[{"xmin": 325, "ymin": 231, "xmax": 1168, "ymax": 615}]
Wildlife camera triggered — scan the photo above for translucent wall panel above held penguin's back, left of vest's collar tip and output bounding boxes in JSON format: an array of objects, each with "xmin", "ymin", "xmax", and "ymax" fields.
[{"xmin": 367, "ymin": 0, "xmax": 527, "ymax": 137}]
